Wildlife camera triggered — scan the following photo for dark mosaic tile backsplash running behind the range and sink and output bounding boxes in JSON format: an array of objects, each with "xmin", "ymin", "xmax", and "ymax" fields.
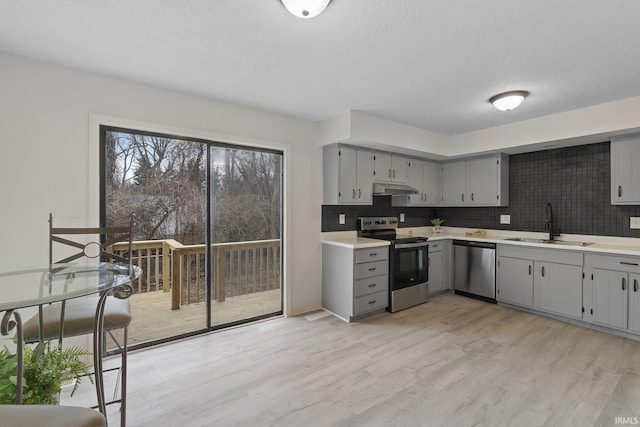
[{"xmin": 322, "ymin": 142, "xmax": 640, "ymax": 237}]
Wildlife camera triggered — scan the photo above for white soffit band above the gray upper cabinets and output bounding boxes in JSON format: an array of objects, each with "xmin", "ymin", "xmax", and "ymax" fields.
[{"xmin": 320, "ymin": 96, "xmax": 640, "ymax": 160}]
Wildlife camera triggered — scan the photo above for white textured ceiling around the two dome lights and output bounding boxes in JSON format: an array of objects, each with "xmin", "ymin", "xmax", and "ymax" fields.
[{"xmin": 0, "ymin": 0, "xmax": 640, "ymax": 135}]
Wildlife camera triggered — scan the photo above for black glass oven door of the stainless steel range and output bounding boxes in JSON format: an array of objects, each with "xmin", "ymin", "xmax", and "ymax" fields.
[{"xmin": 391, "ymin": 242, "xmax": 429, "ymax": 291}]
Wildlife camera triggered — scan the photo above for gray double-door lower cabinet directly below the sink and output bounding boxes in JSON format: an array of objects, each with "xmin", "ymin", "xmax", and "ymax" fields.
[{"xmin": 496, "ymin": 245, "xmax": 584, "ymax": 319}]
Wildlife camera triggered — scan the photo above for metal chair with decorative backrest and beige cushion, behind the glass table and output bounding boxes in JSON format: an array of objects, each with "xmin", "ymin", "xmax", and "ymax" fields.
[{"xmin": 23, "ymin": 214, "xmax": 134, "ymax": 426}]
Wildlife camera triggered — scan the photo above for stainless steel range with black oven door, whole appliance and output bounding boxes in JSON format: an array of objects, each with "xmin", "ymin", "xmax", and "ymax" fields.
[{"xmin": 358, "ymin": 217, "xmax": 429, "ymax": 312}]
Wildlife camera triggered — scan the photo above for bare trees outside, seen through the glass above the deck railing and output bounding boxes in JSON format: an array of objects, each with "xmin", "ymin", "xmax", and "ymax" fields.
[{"xmin": 105, "ymin": 131, "xmax": 282, "ymax": 245}]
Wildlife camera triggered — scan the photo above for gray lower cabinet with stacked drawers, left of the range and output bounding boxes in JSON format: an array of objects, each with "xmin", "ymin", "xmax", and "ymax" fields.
[{"xmin": 322, "ymin": 244, "xmax": 389, "ymax": 322}]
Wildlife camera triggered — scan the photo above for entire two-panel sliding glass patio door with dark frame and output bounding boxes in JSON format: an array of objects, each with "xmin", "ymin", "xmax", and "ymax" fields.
[{"xmin": 101, "ymin": 127, "xmax": 282, "ymax": 348}]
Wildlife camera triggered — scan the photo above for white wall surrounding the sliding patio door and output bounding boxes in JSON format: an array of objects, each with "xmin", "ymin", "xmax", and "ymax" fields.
[{"xmin": 0, "ymin": 53, "xmax": 322, "ymax": 314}]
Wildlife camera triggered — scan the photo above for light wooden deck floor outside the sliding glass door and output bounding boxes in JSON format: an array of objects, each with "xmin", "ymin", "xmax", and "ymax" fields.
[{"xmin": 107, "ymin": 289, "xmax": 281, "ymax": 348}]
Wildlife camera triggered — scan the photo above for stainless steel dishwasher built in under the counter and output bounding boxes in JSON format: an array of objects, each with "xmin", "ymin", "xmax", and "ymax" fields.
[{"xmin": 453, "ymin": 240, "xmax": 496, "ymax": 303}]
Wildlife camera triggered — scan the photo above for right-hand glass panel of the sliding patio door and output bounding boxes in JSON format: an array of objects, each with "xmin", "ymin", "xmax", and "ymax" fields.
[{"xmin": 209, "ymin": 146, "xmax": 282, "ymax": 325}]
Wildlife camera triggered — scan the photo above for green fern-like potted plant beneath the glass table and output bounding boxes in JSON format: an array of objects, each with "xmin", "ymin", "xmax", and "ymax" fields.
[{"xmin": 0, "ymin": 342, "xmax": 93, "ymax": 405}]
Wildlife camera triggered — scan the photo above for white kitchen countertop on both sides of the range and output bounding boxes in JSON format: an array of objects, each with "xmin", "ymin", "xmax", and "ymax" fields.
[{"xmin": 322, "ymin": 227, "xmax": 640, "ymax": 256}]
